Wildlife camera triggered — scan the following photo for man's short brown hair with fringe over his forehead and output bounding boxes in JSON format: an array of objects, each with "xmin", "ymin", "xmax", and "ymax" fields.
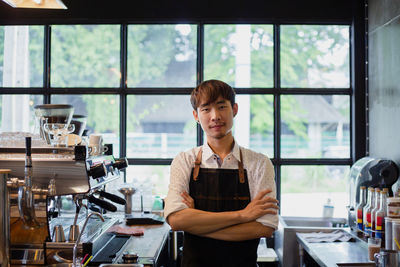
[{"xmin": 190, "ymin": 80, "xmax": 235, "ymax": 110}]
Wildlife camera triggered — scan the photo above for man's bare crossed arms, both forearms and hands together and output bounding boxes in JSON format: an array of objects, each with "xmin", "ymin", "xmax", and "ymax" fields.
[{"xmin": 167, "ymin": 189, "xmax": 278, "ymax": 241}]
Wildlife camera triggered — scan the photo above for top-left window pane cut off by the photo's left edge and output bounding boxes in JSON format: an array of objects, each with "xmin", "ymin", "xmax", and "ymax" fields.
[{"xmin": 0, "ymin": 26, "xmax": 44, "ymax": 87}]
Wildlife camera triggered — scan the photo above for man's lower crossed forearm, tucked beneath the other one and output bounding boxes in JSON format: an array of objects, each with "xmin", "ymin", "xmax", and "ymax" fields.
[{"xmin": 201, "ymin": 221, "xmax": 274, "ymax": 241}]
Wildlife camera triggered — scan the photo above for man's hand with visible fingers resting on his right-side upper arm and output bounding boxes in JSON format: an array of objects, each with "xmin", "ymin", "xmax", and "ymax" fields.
[{"xmin": 239, "ymin": 189, "xmax": 279, "ymax": 222}]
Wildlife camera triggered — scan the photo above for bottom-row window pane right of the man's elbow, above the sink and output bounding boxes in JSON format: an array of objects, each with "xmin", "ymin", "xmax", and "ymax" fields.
[{"xmin": 280, "ymin": 166, "xmax": 350, "ymax": 218}]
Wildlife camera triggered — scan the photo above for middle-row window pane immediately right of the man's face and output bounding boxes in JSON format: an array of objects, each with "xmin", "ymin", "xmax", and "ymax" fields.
[{"xmin": 234, "ymin": 95, "xmax": 274, "ymax": 158}]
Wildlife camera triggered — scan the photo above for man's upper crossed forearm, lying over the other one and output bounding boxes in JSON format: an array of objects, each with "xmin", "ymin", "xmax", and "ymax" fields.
[{"xmin": 168, "ymin": 208, "xmax": 244, "ymax": 235}]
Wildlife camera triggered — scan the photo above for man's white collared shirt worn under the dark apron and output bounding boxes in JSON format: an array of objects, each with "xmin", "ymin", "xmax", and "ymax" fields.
[{"xmin": 164, "ymin": 142, "xmax": 278, "ymax": 229}]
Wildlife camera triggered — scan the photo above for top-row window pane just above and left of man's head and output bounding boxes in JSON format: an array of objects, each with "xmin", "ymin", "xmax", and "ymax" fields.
[{"xmin": 128, "ymin": 24, "xmax": 197, "ymax": 87}]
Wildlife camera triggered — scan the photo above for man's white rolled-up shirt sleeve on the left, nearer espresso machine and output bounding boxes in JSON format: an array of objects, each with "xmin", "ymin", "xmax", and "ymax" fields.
[{"xmin": 164, "ymin": 152, "xmax": 191, "ymax": 221}]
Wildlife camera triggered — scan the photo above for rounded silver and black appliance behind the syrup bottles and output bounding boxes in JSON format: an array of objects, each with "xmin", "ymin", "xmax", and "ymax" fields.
[{"xmin": 347, "ymin": 157, "xmax": 399, "ymax": 231}]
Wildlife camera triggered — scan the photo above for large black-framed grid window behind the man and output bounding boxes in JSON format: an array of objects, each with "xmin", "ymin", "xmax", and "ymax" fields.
[{"xmin": 0, "ymin": 23, "xmax": 355, "ymax": 217}]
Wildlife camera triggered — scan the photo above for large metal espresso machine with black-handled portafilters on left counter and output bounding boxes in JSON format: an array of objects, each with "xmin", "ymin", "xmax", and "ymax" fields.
[{"xmin": 0, "ymin": 138, "xmax": 128, "ymax": 266}]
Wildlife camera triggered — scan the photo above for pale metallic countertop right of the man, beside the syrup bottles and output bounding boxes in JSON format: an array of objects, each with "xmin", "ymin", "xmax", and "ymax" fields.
[{"xmin": 296, "ymin": 230, "xmax": 372, "ymax": 267}]
